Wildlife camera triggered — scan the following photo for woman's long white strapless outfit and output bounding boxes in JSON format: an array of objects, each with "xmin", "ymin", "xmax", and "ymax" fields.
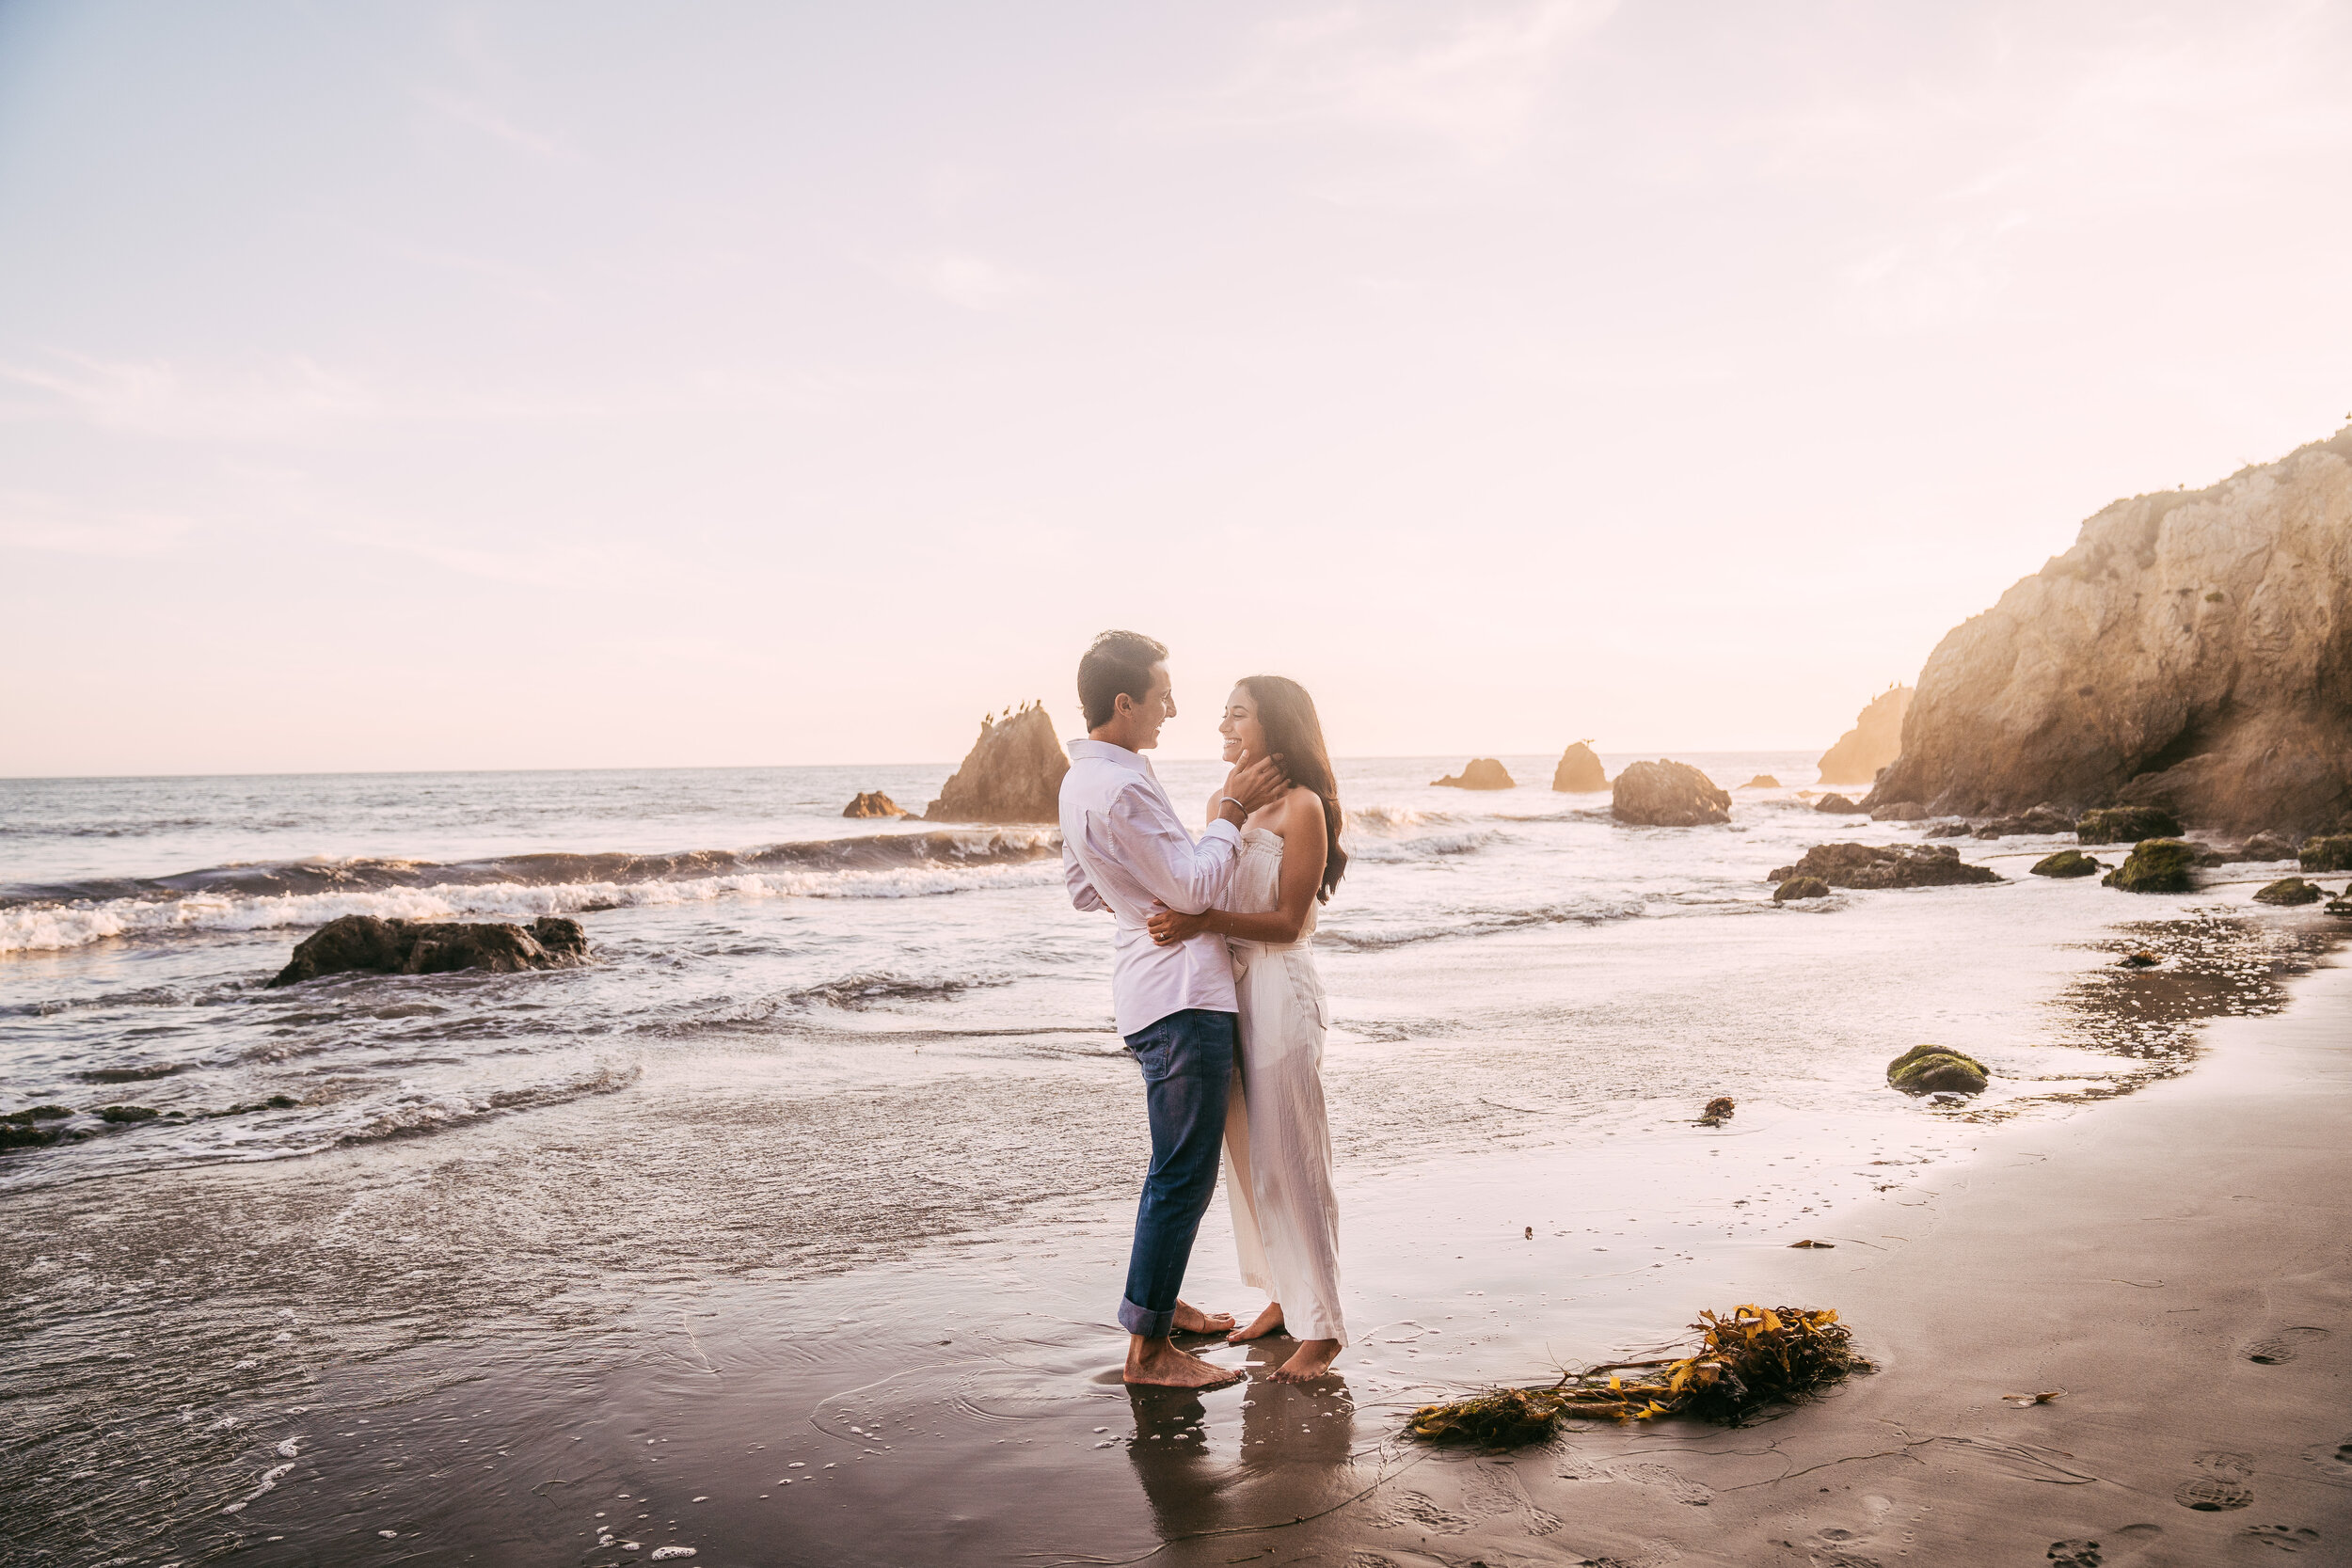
[{"xmin": 1218, "ymin": 828, "xmax": 1348, "ymax": 1345}]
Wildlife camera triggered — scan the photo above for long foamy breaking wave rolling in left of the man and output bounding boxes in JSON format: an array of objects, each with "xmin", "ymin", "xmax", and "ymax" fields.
[{"xmin": 0, "ymin": 828, "xmax": 1061, "ymax": 952}]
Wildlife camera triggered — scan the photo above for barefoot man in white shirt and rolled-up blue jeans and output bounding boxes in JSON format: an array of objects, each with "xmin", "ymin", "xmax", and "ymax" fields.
[{"xmin": 1061, "ymin": 632, "xmax": 1289, "ymax": 1389}]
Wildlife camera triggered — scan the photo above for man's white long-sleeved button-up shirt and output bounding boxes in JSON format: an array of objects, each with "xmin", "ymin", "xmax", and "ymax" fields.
[{"xmin": 1061, "ymin": 740, "xmax": 1242, "ymax": 1035}]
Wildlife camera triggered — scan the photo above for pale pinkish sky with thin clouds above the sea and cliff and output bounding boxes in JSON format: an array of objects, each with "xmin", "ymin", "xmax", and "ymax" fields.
[{"xmin": 0, "ymin": 0, "xmax": 2352, "ymax": 776}]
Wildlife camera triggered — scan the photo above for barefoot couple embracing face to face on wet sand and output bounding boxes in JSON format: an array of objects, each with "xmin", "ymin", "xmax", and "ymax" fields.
[{"xmin": 1061, "ymin": 632, "xmax": 1348, "ymax": 1389}]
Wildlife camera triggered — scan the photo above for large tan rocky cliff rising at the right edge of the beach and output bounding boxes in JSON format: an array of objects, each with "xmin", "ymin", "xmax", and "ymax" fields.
[{"xmin": 1867, "ymin": 425, "xmax": 2352, "ymax": 832}]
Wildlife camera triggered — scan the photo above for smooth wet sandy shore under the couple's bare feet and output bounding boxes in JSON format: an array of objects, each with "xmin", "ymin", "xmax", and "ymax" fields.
[{"xmin": 0, "ymin": 911, "xmax": 2352, "ymax": 1568}]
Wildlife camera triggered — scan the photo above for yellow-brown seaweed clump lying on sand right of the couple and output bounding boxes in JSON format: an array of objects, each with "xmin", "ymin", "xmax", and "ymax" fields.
[{"xmin": 1406, "ymin": 1305, "xmax": 1872, "ymax": 1449}]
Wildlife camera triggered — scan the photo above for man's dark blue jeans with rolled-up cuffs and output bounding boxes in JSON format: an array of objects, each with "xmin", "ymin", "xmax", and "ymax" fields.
[{"xmin": 1120, "ymin": 1006, "xmax": 1240, "ymax": 1340}]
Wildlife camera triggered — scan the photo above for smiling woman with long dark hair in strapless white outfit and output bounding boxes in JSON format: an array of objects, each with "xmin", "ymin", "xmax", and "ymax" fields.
[{"xmin": 1151, "ymin": 674, "xmax": 1348, "ymax": 1383}]
